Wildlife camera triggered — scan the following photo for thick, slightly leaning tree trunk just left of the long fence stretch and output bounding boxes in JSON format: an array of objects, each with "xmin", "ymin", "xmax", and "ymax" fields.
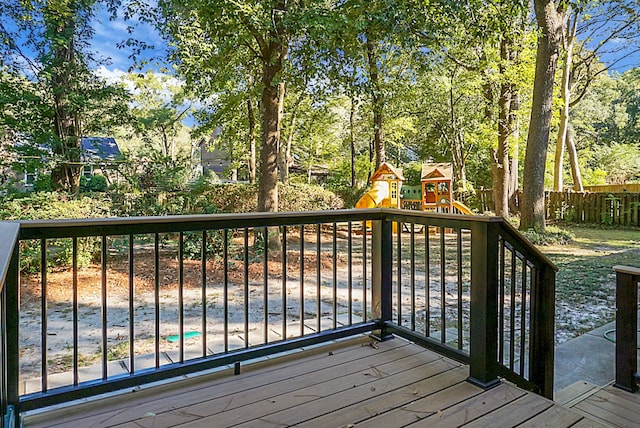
[{"xmin": 520, "ymin": 0, "xmax": 566, "ymax": 230}]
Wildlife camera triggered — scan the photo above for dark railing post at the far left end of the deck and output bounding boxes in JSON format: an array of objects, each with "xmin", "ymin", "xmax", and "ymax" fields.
[{"xmin": 2, "ymin": 243, "xmax": 20, "ymax": 427}]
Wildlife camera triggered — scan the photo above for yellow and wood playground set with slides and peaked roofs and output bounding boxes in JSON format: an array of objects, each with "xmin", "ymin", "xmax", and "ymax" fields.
[{"xmin": 356, "ymin": 162, "xmax": 473, "ymax": 215}]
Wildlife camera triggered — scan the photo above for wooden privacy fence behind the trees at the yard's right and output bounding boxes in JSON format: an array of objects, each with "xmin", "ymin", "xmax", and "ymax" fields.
[{"xmin": 466, "ymin": 190, "xmax": 640, "ymax": 226}]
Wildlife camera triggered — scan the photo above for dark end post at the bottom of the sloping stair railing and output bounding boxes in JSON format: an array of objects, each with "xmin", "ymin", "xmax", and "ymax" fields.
[{"xmin": 529, "ymin": 264, "xmax": 556, "ymax": 399}]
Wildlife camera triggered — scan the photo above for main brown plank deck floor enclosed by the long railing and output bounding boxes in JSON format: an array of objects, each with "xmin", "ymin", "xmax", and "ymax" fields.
[{"xmin": 25, "ymin": 337, "xmax": 612, "ymax": 428}]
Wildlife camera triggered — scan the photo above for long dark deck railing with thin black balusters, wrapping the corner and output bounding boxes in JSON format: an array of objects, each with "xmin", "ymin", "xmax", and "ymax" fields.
[{"xmin": 0, "ymin": 209, "xmax": 555, "ymax": 424}]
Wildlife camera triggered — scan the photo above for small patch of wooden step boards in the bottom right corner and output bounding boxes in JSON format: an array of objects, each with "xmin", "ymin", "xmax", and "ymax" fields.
[{"xmin": 556, "ymin": 382, "xmax": 640, "ymax": 427}]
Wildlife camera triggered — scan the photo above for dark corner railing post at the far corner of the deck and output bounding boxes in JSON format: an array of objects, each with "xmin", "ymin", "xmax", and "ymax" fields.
[{"xmin": 371, "ymin": 219, "xmax": 393, "ymax": 341}]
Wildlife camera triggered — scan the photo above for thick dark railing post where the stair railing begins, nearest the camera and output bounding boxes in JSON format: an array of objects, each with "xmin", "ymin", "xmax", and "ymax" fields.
[{"xmin": 467, "ymin": 221, "xmax": 500, "ymax": 389}]
